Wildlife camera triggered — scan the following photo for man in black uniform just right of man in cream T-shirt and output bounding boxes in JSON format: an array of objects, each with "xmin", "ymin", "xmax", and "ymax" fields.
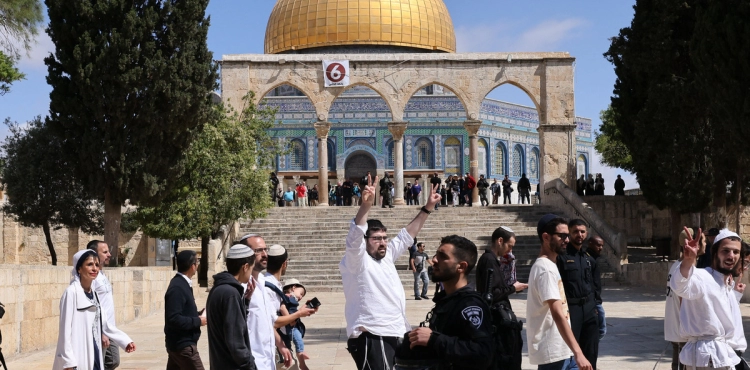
[{"xmin": 557, "ymin": 219, "xmax": 599, "ymax": 369}]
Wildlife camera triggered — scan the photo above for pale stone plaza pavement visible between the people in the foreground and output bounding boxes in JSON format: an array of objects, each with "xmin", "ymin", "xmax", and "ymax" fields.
[{"xmin": 8, "ymin": 286, "xmax": 750, "ymax": 370}]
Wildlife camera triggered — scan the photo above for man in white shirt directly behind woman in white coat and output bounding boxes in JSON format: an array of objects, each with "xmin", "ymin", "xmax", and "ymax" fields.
[{"xmin": 86, "ymin": 240, "xmax": 135, "ymax": 370}]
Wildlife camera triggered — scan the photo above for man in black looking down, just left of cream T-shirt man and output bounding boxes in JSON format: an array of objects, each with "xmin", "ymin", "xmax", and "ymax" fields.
[{"xmin": 477, "ymin": 226, "xmax": 529, "ymax": 370}]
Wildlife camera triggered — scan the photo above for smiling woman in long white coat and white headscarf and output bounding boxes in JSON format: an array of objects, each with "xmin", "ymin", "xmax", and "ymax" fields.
[{"xmin": 52, "ymin": 250, "xmax": 104, "ymax": 370}]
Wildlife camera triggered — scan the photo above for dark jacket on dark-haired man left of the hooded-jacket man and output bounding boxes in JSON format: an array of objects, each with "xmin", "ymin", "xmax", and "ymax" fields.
[{"xmin": 164, "ymin": 274, "xmax": 201, "ymax": 352}]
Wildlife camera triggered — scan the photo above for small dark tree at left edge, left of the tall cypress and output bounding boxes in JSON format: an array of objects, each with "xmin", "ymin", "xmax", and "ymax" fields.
[{"xmin": 2, "ymin": 117, "xmax": 102, "ymax": 265}]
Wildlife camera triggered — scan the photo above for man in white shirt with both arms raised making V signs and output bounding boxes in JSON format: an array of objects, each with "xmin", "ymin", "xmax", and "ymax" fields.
[{"xmin": 339, "ymin": 177, "xmax": 440, "ymax": 370}]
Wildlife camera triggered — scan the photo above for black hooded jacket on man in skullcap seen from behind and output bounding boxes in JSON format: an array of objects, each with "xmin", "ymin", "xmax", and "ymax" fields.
[{"xmin": 206, "ymin": 271, "xmax": 256, "ymax": 370}]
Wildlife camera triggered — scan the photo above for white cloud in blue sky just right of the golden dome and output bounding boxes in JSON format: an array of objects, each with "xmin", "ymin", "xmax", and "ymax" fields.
[{"xmin": 456, "ymin": 18, "xmax": 586, "ymax": 52}]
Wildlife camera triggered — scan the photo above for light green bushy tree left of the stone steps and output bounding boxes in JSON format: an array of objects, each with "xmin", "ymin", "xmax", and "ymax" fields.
[{"xmin": 136, "ymin": 93, "xmax": 279, "ymax": 284}]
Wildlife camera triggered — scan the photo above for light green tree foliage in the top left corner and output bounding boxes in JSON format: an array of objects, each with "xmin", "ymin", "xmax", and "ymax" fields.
[{"xmin": 0, "ymin": 0, "xmax": 44, "ymax": 96}]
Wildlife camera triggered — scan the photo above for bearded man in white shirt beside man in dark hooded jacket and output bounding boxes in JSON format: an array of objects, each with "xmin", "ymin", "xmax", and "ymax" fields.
[{"xmin": 238, "ymin": 234, "xmax": 292, "ymax": 370}]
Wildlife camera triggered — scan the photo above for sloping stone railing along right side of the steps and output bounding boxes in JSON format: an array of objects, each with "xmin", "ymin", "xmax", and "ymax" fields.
[{"xmin": 542, "ymin": 179, "xmax": 628, "ymax": 273}]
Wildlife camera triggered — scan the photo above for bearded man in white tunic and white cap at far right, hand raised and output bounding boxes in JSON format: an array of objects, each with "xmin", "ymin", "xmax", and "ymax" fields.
[{"xmin": 669, "ymin": 228, "xmax": 747, "ymax": 370}]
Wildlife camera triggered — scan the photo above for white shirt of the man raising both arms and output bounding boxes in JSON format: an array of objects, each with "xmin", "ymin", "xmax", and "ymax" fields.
[{"xmin": 339, "ymin": 220, "xmax": 414, "ymax": 338}]
